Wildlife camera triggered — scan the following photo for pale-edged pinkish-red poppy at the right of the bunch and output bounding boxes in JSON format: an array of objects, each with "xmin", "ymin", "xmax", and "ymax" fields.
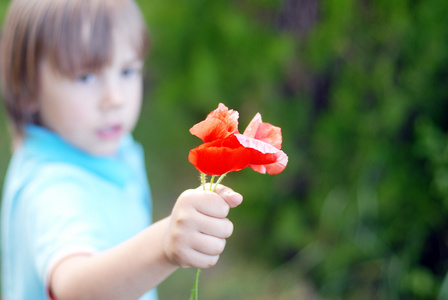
[{"xmin": 240, "ymin": 113, "xmax": 288, "ymax": 175}]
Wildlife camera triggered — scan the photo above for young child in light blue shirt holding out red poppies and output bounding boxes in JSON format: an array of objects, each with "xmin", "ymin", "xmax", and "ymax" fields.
[{"xmin": 0, "ymin": 0, "xmax": 242, "ymax": 300}]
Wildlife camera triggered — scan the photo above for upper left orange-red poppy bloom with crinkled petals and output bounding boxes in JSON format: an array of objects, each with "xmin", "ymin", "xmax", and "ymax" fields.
[{"xmin": 190, "ymin": 103, "xmax": 239, "ymax": 143}]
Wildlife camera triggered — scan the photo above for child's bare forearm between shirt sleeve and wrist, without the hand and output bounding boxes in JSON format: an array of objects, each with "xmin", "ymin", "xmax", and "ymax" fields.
[{"xmin": 50, "ymin": 218, "xmax": 178, "ymax": 300}]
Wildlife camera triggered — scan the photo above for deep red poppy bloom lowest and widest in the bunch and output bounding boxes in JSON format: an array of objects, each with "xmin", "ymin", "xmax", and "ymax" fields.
[{"xmin": 188, "ymin": 134, "xmax": 278, "ymax": 175}]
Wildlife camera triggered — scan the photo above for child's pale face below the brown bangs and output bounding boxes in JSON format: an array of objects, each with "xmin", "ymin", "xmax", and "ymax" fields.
[{"xmin": 38, "ymin": 33, "xmax": 143, "ymax": 155}]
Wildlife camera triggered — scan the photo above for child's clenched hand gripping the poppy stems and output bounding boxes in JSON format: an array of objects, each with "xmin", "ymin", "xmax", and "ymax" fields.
[{"xmin": 165, "ymin": 185, "xmax": 243, "ymax": 268}]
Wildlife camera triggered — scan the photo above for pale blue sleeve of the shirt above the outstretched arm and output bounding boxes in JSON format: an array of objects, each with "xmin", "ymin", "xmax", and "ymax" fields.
[{"xmin": 23, "ymin": 172, "xmax": 105, "ymax": 287}]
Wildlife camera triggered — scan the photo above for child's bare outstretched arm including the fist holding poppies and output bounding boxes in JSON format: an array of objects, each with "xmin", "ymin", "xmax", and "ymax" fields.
[{"xmin": 50, "ymin": 186, "xmax": 242, "ymax": 300}]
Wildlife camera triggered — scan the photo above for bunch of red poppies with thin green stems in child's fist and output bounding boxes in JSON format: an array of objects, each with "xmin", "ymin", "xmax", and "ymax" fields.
[{"xmin": 188, "ymin": 103, "xmax": 288, "ymax": 300}]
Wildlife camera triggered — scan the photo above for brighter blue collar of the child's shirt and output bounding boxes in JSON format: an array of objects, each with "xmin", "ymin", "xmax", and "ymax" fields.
[{"xmin": 23, "ymin": 125, "xmax": 135, "ymax": 186}]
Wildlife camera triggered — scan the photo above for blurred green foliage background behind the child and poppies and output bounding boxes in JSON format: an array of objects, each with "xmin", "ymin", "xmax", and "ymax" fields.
[{"xmin": 0, "ymin": 0, "xmax": 448, "ymax": 300}]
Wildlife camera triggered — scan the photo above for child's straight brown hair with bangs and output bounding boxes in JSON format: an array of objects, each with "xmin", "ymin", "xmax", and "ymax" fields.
[{"xmin": 0, "ymin": 0, "xmax": 148, "ymax": 137}]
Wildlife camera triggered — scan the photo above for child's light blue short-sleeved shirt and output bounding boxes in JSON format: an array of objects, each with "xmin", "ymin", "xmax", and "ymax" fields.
[{"xmin": 2, "ymin": 126, "xmax": 157, "ymax": 300}]
